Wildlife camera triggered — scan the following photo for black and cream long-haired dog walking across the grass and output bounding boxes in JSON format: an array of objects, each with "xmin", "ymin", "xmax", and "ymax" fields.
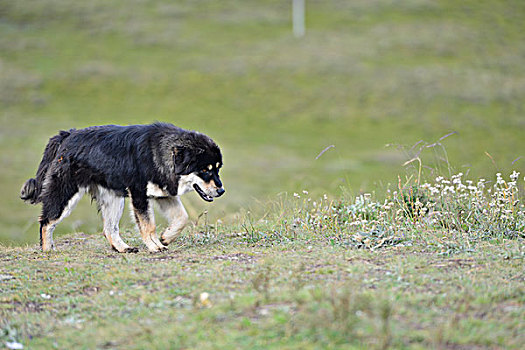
[{"xmin": 20, "ymin": 123, "xmax": 225, "ymax": 253}]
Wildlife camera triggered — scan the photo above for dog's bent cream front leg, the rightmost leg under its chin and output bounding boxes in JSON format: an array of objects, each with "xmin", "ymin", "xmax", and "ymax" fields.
[{"xmin": 156, "ymin": 196, "xmax": 188, "ymax": 245}]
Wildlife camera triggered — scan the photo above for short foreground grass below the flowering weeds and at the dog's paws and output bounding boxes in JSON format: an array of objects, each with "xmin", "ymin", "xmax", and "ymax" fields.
[{"xmin": 0, "ymin": 232, "xmax": 525, "ymax": 349}]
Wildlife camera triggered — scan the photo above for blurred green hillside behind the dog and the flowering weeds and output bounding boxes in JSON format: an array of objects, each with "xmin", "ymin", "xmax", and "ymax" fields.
[{"xmin": 0, "ymin": 0, "xmax": 525, "ymax": 245}]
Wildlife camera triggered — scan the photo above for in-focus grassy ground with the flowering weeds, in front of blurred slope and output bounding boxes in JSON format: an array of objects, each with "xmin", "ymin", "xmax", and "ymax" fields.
[{"xmin": 0, "ymin": 173, "xmax": 525, "ymax": 349}]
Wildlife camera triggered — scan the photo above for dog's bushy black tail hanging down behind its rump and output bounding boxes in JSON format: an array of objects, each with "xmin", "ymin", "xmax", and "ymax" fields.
[{"xmin": 20, "ymin": 130, "xmax": 73, "ymax": 204}]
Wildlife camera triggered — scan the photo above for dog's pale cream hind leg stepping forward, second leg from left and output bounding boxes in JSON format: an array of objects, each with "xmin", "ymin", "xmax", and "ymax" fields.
[{"xmin": 91, "ymin": 186, "xmax": 139, "ymax": 253}]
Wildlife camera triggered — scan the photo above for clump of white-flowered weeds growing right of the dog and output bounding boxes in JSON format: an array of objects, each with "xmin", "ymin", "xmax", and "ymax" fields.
[{"xmin": 292, "ymin": 171, "xmax": 525, "ymax": 249}]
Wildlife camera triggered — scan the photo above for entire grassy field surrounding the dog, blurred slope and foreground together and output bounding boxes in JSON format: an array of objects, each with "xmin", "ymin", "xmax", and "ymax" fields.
[{"xmin": 0, "ymin": 0, "xmax": 525, "ymax": 349}]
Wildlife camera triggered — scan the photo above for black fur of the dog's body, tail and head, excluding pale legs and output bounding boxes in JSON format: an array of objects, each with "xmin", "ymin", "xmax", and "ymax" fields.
[{"xmin": 20, "ymin": 123, "xmax": 222, "ymax": 225}]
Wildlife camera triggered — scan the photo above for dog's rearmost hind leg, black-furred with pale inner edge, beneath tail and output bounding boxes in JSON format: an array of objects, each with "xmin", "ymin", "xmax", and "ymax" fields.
[{"xmin": 39, "ymin": 186, "xmax": 86, "ymax": 252}]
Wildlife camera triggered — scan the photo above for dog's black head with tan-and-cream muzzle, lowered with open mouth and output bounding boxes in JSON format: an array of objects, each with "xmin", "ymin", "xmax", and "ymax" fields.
[{"xmin": 174, "ymin": 133, "xmax": 225, "ymax": 202}]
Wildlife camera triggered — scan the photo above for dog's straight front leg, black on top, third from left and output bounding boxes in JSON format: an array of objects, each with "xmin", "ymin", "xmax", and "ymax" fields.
[{"xmin": 131, "ymin": 191, "xmax": 168, "ymax": 253}]
